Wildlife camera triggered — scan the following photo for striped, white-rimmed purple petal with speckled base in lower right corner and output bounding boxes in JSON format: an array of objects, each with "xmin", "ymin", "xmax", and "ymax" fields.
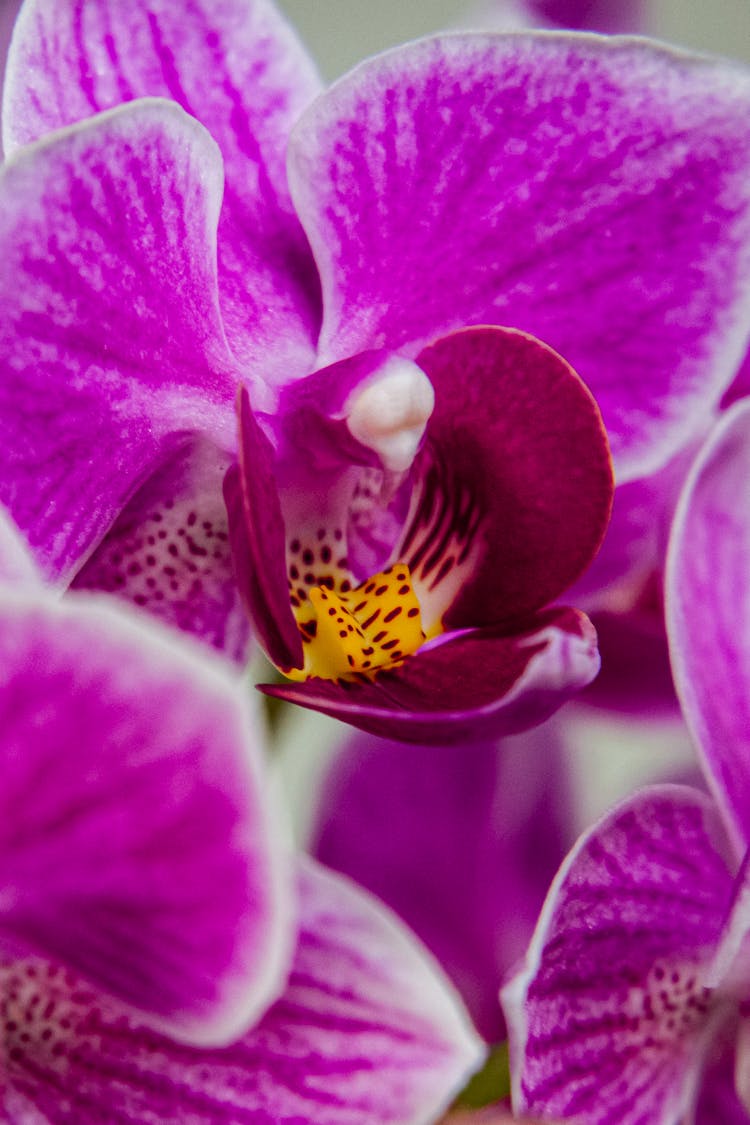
[{"xmin": 504, "ymin": 786, "xmax": 732, "ymax": 1125}]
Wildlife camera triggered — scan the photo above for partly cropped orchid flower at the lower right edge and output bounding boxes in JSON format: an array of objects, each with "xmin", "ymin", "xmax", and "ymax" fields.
[{"xmin": 504, "ymin": 402, "xmax": 750, "ymax": 1125}]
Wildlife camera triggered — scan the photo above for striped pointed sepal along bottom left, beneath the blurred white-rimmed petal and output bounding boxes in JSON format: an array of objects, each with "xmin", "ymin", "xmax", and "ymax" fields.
[{"xmin": 3, "ymin": 869, "xmax": 481, "ymax": 1125}]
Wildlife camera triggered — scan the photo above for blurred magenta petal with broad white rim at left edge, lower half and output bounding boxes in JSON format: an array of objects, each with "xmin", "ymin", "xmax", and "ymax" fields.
[{"xmin": 0, "ymin": 591, "xmax": 290, "ymax": 1044}]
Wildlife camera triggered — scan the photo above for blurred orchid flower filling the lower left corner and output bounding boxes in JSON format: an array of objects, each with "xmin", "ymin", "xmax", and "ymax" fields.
[{"xmin": 0, "ymin": 518, "xmax": 482, "ymax": 1125}]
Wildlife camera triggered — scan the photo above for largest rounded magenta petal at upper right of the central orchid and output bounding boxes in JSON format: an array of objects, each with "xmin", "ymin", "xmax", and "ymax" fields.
[{"xmin": 290, "ymin": 35, "xmax": 750, "ymax": 479}]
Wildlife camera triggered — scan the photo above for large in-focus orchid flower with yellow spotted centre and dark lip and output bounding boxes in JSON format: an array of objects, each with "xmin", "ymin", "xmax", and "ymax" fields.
[{"xmin": 0, "ymin": 0, "xmax": 750, "ymax": 740}]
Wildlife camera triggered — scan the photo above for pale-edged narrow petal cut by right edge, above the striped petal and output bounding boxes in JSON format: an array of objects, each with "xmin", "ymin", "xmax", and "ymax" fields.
[{"xmin": 666, "ymin": 401, "xmax": 750, "ymax": 846}]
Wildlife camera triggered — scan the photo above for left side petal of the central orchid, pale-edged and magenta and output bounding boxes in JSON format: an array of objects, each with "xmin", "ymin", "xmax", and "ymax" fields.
[{"xmin": 0, "ymin": 101, "xmax": 235, "ymax": 577}]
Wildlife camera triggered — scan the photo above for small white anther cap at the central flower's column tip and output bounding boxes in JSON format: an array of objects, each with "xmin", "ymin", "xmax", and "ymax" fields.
[{"xmin": 346, "ymin": 356, "xmax": 435, "ymax": 473}]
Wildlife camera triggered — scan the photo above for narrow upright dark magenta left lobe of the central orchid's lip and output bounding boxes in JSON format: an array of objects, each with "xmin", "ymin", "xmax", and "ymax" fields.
[{"xmin": 224, "ymin": 388, "xmax": 304, "ymax": 668}]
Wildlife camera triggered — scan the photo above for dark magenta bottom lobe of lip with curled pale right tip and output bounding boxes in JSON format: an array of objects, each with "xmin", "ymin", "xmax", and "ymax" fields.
[{"xmin": 260, "ymin": 610, "xmax": 599, "ymax": 744}]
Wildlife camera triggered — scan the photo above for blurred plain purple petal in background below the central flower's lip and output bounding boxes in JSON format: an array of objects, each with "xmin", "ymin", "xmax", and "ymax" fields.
[{"xmin": 313, "ymin": 728, "xmax": 572, "ymax": 1043}]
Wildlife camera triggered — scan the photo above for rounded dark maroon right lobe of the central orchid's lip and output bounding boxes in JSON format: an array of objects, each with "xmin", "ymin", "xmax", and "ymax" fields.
[{"xmin": 413, "ymin": 327, "xmax": 613, "ymax": 629}]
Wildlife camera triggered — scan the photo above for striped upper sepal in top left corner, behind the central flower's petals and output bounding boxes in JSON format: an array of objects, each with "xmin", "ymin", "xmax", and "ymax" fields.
[{"xmin": 3, "ymin": 0, "xmax": 319, "ymax": 378}]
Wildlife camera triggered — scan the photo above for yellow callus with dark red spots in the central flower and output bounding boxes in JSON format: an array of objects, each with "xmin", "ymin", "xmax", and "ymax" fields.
[{"xmin": 287, "ymin": 563, "xmax": 425, "ymax": 681}]
